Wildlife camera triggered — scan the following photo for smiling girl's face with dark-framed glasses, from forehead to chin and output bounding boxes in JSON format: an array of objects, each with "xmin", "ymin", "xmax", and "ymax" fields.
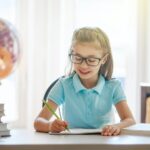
[{"xmin": 72, "ymin": 43, "xmax": 105, "ymax": 81}]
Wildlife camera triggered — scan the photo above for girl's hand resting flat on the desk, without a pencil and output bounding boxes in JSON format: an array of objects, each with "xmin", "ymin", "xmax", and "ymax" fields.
[{"xmin": 101, "ymin": 125, "xmax": 121, "ymax": 136}]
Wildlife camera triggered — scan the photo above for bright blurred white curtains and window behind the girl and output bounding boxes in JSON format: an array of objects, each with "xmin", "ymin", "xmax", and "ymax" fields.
[{"xmin": 0, "ymin": 0, "xmax": 150, "ymax": 128}]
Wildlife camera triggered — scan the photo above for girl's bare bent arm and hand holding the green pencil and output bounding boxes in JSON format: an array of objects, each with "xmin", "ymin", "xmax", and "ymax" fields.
[{"xmin": 34, "ymin": 100, "xmax": 67, "ymax": 132}]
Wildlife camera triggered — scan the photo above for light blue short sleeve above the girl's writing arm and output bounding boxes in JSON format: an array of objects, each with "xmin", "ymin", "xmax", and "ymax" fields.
[{"xmin": 48, "ymin": 79, "xmax": 64, "ymax": 105}]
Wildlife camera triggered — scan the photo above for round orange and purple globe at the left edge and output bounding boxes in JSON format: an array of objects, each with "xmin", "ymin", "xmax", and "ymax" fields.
[{"xmin": 0, "ymin": 19, "xmax": 20, "ymax": 80}]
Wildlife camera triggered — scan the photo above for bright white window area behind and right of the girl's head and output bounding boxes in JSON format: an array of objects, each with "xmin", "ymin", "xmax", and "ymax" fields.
[{"xmin": 73, "ymin": 0, "xmax": 137, "ymax": 118}]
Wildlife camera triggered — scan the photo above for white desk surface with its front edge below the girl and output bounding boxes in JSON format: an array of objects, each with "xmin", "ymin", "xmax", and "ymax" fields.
[{"xmin": 0, "ymin": 129, "xmax": 150, "ymax": 150}]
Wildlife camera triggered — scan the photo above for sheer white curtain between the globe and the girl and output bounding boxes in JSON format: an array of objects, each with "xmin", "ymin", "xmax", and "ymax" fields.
[{"xmin": 14, "ymin": 0, "xmax": 75, "ymax": 128}]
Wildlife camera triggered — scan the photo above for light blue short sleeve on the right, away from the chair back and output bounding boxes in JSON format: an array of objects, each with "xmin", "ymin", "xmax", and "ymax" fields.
[{"xmin": 113, "ymin": 80, "xmax": 126, "ymax": 104}]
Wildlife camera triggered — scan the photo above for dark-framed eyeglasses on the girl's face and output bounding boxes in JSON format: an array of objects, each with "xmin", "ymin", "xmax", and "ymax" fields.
[{"xmin": 69, "ymin": 53, "xmax": 101, "ymax": 66}]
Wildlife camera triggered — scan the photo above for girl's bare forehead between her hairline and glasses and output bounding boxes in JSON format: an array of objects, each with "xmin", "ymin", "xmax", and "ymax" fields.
[{"xmin": 72, "ymin": 43, "xmax": 103, "ymax": 56}]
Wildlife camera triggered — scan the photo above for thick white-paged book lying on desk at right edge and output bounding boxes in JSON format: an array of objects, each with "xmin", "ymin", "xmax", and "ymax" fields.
[{"xmin": 121, "ymin": 123, "xmax": 150, "ymax": 136}]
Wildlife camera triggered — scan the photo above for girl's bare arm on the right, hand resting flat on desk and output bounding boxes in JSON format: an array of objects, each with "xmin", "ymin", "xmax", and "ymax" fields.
[{"xmin": 102, "ymin": 101, "xmax": 135, "ymax": 136}]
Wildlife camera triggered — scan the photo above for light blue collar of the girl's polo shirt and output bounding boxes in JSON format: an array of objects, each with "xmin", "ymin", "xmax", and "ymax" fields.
[{"xmin": 73, "ymin": 73, "xmax": 105, "ymax": 95}]
